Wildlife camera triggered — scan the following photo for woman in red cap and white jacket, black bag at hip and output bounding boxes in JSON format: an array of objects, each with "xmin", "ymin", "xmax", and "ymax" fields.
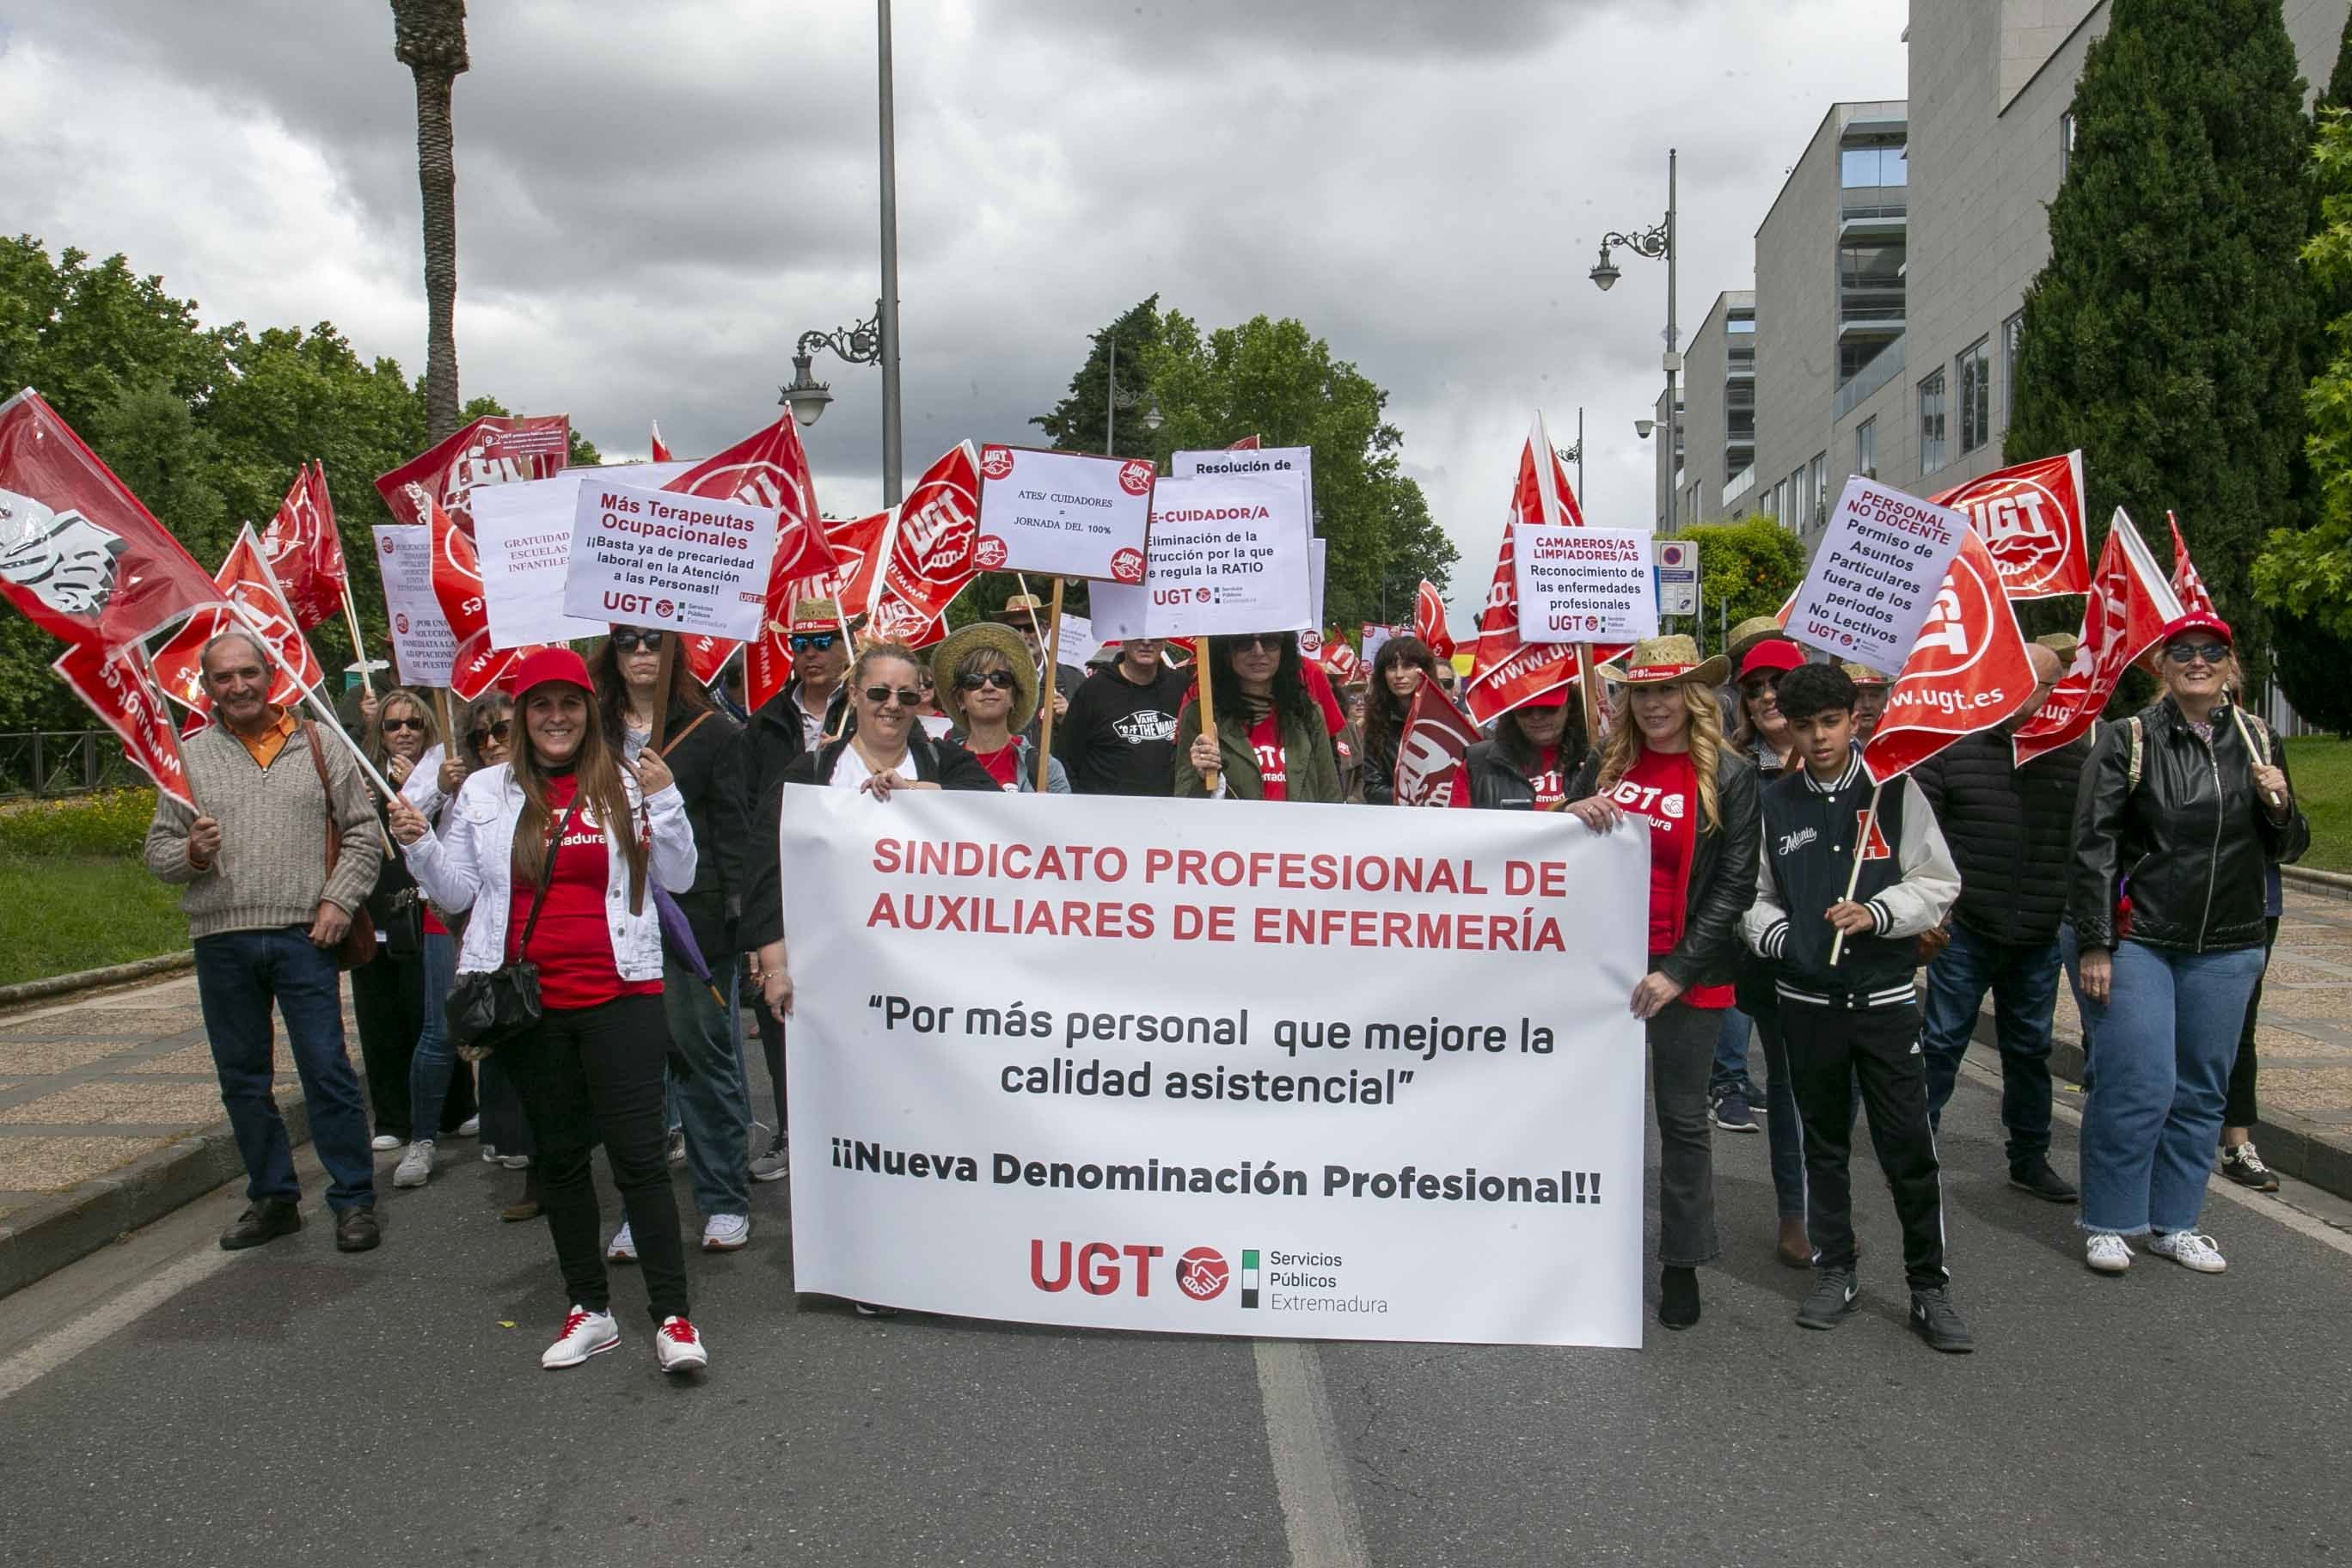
[{"xmin": 390, "ymin": 649, "xmax": 710, "ymax": 1373}]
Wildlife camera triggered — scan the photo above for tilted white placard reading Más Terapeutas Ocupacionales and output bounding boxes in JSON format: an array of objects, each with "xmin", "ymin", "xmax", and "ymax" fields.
[{"xmin": 562, "ymin": 484, "xmax": 779, "ymax": 642}]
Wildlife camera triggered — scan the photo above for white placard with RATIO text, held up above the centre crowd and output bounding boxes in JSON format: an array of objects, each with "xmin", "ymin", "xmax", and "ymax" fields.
[{"xmin": 1089, "ymin": 475, "xmax": 1314, "ymax": 637}]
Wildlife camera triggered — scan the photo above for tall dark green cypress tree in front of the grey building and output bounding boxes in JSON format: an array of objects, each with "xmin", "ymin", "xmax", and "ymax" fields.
[{"xmin": 2006, "ymin": 0, "xmax": 2310, "ymax": 677}]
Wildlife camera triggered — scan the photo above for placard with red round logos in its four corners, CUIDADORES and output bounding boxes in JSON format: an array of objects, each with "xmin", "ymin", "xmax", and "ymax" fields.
[{"xmin": 974, "ymin": 447, "xmax": 1157, "ymax": 583}]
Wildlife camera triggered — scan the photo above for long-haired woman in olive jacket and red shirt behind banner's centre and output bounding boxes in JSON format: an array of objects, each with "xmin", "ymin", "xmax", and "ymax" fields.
[{"xmin": 1176, "ymin": 633, "xmax": 1341, "ymax": 802}]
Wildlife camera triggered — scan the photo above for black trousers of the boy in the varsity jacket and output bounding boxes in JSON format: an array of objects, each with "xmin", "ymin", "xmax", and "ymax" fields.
[{"xmin": 1780, "ymin": 996, "xmax": 1950, "ymax": 1290}]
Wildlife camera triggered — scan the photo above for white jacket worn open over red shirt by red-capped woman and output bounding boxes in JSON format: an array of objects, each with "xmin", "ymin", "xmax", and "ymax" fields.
[{"xmin": 402, "ymin": 762, "xmax": 694, "ymax": 980}]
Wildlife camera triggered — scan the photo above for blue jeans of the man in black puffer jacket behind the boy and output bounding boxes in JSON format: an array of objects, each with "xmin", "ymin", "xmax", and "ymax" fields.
[{"xmin": 1920, "ymin": 922, "xmax": 2058, "ymax": 1166}]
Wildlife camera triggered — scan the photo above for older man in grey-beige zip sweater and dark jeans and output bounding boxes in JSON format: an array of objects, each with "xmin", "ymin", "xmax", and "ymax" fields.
[{"xmin": 146, "ymin": 630, "xmax": 383, "ymax": 1253}]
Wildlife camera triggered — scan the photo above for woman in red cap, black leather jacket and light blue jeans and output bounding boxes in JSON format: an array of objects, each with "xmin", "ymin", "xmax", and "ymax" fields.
[{"xmin": 2067, "ymin": 611, "xmax": 2310, "ymax": 1274}]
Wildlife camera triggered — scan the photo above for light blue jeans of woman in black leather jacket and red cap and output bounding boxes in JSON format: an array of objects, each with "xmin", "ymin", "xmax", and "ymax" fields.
[{"xmin": 2081, "ymin": 938, "xmax": 2265, "ymax": 1236}]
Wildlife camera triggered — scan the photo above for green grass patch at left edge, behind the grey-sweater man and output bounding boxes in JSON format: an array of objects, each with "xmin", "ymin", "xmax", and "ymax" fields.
[{"xmin": 0, "ymin": 848, "xmax": 188, "ymax": 985}]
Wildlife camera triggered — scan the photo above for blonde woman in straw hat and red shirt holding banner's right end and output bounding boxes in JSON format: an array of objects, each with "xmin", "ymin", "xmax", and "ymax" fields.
[{"xmin": 1569, "ymin": 637, "xmax": 1757, "ymax": 1328}]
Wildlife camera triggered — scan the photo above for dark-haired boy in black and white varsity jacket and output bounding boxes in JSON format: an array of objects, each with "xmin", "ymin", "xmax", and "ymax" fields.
[{"xmin": 1741, "ymin": 663, "xmax": 1975, "ymax": 1351}]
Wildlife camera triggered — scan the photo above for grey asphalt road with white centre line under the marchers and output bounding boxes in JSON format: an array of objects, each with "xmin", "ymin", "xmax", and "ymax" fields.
[{"xmin": 0, "ymin": 1044, "xmax": 2352, "ymax": 1568}]
